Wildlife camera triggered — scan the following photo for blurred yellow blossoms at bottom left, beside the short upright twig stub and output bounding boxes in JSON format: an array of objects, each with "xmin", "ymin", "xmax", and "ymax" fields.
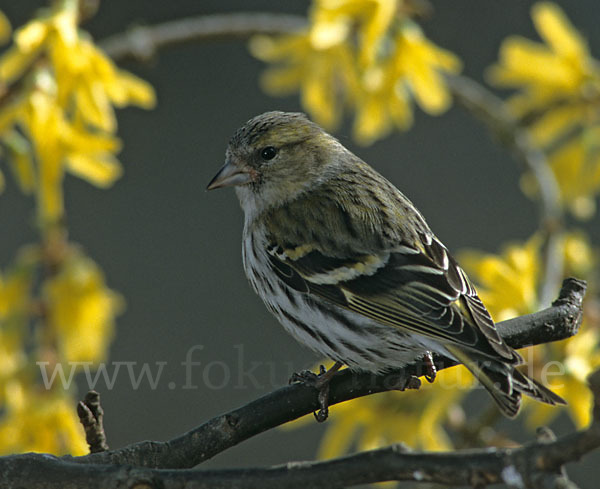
[{"xmin": 0, "ymin": 381, "xmax": 88, "ymax": 455}]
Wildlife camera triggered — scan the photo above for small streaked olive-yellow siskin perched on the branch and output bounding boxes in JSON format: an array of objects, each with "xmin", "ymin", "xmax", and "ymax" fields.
[{"xmin": 207, "ymin": 111, "xmax": 565, "ymax": 421}]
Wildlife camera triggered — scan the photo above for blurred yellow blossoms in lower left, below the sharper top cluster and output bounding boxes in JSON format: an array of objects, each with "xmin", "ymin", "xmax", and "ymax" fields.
[{"xmin": 0, "ymin": 240, "xmax": 122, "ymax": 454}]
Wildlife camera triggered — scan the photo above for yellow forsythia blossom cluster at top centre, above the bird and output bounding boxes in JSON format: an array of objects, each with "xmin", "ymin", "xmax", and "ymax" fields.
[{"xmin": 250, "ymin": 0, "xmax": 460, "ymax": 144}]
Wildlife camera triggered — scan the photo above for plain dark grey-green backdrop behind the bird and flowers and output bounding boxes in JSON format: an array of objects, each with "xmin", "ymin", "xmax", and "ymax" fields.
[{"xmin": 0, "ymin": 0, "xmax": 600, "ymax": 480}]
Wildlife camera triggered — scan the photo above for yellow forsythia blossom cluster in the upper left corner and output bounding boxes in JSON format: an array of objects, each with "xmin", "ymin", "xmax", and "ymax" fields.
[{"xmin": 0, "ymin": 0, "xmax": 155, "ymax": 222}]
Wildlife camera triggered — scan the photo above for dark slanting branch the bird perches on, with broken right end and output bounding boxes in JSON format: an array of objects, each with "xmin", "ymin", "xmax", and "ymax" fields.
[{"xmin": 45, "ymin": 279, "xmax": 586, "ymax": 473}]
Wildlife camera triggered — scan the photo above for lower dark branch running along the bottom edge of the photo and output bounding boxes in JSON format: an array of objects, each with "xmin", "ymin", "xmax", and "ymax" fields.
[{"xmin": 0, "ymin": 350, "xmax": 600, "ymax": 489}]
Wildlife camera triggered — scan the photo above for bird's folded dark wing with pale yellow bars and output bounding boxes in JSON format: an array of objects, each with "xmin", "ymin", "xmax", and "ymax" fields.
[{"xmin": 267, "ymin": 219, "xmax": 520, "ymax": 363}]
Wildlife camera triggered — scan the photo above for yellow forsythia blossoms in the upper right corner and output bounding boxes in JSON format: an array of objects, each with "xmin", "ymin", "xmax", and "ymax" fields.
[{"xmin": 490, "ymin": 2, "xmax": 600, "ymax": 218}]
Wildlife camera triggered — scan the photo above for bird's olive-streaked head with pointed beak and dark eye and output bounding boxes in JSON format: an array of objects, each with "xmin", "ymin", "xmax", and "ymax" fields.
[{"xmin": 207, "ymin": 112, "xmax": 346, "ymax": 215}]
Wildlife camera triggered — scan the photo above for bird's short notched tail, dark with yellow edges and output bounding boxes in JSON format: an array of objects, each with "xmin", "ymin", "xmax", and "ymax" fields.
[{"xmin": 446, "ymin": 345, "xmax": 566, "ymax": 418}]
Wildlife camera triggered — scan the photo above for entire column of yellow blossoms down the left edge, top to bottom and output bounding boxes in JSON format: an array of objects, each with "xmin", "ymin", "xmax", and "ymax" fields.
[{"xmin": 0, "ymin": 0, "xmax": 149, "ymax": 454}]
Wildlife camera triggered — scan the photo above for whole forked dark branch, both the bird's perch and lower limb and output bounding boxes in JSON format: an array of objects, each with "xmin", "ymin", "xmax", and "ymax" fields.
[{"xmin": 0, "ymin": 279, "xmax": 584, "ymax": 489}]
